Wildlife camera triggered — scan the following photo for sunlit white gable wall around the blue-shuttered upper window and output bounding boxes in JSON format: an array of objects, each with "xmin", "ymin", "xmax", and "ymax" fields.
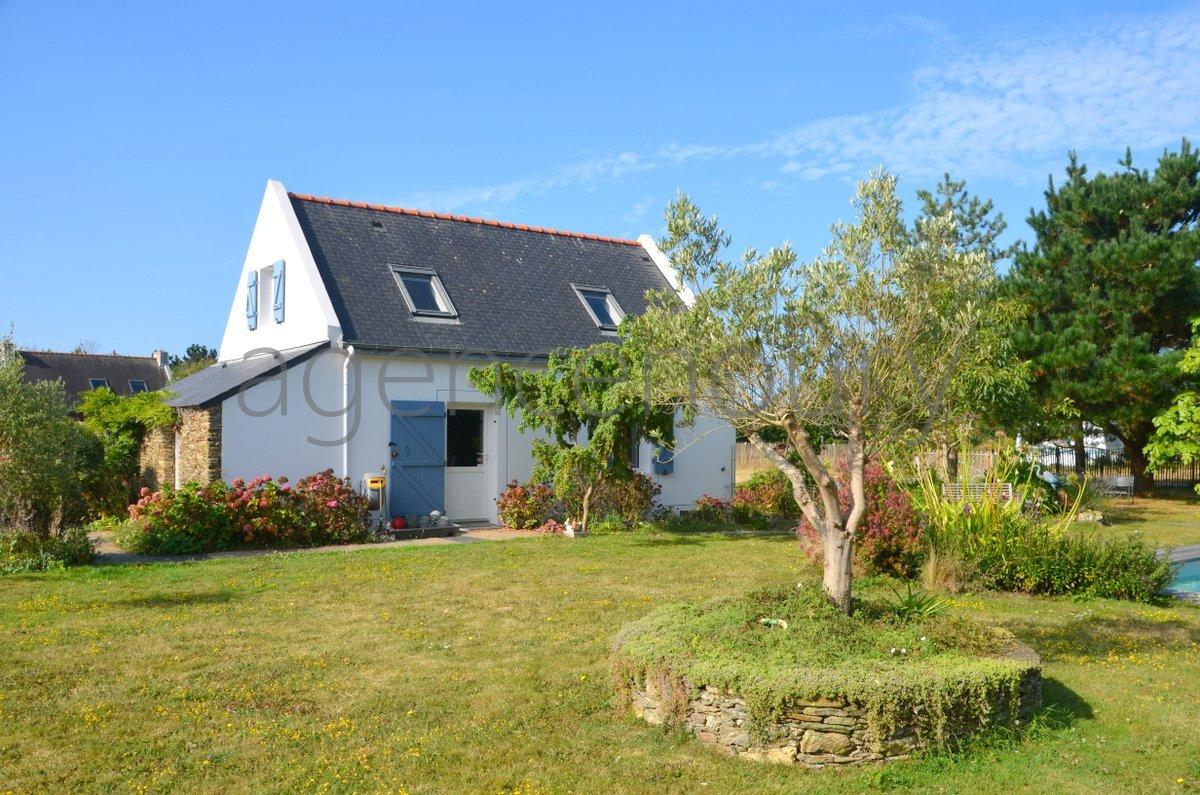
[{"xmin": 218, "ymin": 180, "xmax": 341, "ymax": 361}]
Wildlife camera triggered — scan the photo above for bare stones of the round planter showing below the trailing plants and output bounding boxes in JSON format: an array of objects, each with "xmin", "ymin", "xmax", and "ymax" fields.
[{"xmin": 632, "ymin": 668, "xmax": 1042, "ymax": 767}]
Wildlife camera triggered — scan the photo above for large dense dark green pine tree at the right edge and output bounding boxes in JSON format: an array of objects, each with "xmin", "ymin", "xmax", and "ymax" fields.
[{"xmin": 1008, "ymin": 139, "xmax": 1200, "ymax": 491}]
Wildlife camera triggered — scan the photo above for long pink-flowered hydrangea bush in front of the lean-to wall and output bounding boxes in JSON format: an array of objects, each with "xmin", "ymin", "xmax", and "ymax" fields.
[{"xmin": 123, "ymin": 470, "xmax": 370, "ymax": 555}]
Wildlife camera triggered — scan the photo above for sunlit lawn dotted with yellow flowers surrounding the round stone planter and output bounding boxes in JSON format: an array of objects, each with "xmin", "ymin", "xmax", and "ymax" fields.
[{"xmin": 0, "ymin": 513, "xmax": 1200, "ymax": 793}]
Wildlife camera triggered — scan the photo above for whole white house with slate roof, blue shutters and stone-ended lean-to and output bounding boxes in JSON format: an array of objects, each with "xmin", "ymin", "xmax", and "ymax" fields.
[{"xmin": 170, "ymin": 180, "xmax": 734, "ymax": 521}]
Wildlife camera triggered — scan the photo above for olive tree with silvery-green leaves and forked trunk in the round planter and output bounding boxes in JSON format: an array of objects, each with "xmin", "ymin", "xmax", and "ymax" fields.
[{"xmin": 623, "ymin": 172, "xmax": 991, "ymax": 612}]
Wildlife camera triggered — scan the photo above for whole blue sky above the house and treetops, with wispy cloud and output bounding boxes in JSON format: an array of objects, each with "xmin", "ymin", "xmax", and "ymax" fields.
[{"xmin": 0, "ymin": 0, "xmax": 1200, "ymax": 353}]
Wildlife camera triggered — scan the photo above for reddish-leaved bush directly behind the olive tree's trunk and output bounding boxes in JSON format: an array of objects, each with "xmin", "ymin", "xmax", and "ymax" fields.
[{"xmin": 796, "ymin": 461, "xmax": 924, "ymax": 576}]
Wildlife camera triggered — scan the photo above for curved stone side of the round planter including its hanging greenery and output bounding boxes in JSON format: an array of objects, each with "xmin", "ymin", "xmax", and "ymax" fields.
[{"xmin": 613, "ymin": 600, "xmax": 1042, "ymax": 767}]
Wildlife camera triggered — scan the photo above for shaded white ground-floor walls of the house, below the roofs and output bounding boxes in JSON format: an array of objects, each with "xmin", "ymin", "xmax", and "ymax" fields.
[{"xmin": 222, "ymin": 347, "xmax": 734, "ymax": 521}]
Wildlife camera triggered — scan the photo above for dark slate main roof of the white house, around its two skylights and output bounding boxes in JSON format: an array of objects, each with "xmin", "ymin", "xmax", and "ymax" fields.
[{"xmin": 289, "ymin": 193, "xmax": 671, "ymax": 355}]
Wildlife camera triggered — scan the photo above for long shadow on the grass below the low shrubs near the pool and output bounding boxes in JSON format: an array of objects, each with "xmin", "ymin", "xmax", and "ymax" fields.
[{"xmin": 1003, "ymin": 612, "xmax": 1200, "ymax": 660}]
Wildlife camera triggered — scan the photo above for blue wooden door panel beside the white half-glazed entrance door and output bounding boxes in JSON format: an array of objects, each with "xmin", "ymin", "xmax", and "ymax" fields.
[{"xmin": 388, "ymin": 400, "xmax": 446, "ymax": 516}]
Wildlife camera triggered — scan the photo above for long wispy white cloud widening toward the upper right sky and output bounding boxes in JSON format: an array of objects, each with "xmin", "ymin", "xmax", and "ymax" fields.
[{"xmin": 396, "ymin": 7, "xmax": 1200, "ymax": 210}]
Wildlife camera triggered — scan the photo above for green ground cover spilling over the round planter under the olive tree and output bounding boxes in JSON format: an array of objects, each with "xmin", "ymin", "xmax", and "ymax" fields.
[{"xmin": 613, "ymin": 584, "xmax": 1028, "ymax": 742}]
